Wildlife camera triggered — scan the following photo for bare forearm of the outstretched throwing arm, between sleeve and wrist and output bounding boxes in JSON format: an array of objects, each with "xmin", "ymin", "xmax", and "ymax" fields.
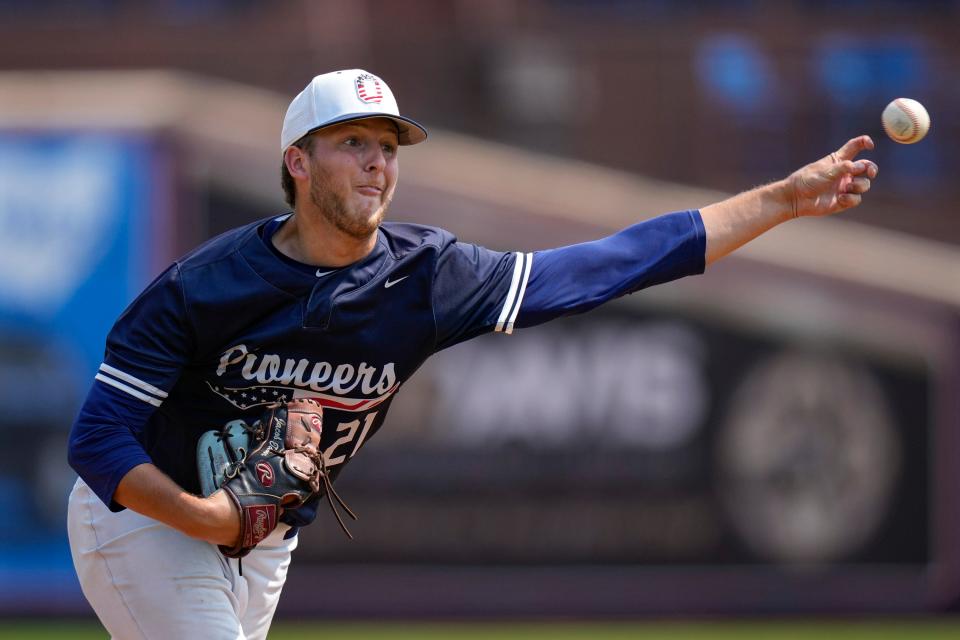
[{"xmin": 700, "ymin": 180, "xmax": 794, "ymax": 265}]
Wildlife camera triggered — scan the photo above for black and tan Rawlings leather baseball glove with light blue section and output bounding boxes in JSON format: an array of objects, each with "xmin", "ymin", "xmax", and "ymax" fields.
[{"xmin": 197, "ymin": 399, "xmax": 356, "ymax": 558}]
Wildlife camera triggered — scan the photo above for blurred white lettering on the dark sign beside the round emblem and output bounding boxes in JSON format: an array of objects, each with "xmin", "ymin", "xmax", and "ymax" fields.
[{"xmin": 431, "ymin": 324, "xmax": 709, "ymax": 450}]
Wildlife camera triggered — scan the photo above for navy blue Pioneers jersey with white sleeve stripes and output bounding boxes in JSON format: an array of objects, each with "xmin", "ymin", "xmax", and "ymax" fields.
[{"xmin": 70, "ymin": 211, "xmax": 705, "ymax": 525}]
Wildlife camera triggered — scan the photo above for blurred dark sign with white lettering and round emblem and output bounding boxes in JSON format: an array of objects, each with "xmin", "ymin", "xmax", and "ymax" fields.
[{"xmin": 282, "ymin": 294, "xmax": 953, "ymax": 615}]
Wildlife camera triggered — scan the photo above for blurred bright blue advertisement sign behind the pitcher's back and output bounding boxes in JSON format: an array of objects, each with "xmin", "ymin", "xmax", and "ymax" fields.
[{"xmin": 0, "ymin": 131, "xmax": 167, "ymax": 610}]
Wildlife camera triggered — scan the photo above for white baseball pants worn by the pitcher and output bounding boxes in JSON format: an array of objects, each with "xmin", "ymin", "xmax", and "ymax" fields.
[{"xmin": 67, "ymin": 479, "xmax": 297, "ymax": 640}]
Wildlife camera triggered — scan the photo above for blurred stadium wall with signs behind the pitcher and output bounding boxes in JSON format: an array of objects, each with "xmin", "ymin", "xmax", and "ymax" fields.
[{"xmin": 0, "ymin": 0, "xmax": 960, "ymax": 617}]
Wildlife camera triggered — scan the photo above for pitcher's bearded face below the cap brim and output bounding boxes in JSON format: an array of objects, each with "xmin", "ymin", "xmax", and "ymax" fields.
[{"xmin": 310, "ymin": 118, "xmax": 398, "ymax": 239}]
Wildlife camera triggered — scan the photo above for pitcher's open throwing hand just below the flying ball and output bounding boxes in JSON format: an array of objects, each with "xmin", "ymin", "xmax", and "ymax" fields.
[{"xmin": 787, "ymin": 136, "xmax": 879, "ymax": 218}]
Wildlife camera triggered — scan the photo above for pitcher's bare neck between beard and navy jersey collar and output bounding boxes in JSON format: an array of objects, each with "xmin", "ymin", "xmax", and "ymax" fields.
[{"xmin": 272, "ymin": 206, "xmax": 377, "ymax": 267}]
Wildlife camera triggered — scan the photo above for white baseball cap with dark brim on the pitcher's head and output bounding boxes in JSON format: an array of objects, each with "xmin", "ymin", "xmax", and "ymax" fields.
[{"xmin": 280, "ymin": 69, "xmax": 427, "ymax": 153}]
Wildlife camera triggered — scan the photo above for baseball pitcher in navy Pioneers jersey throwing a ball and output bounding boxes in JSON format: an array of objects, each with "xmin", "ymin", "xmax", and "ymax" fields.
[{"xmin": 68, "ymin": 69, "xmax": 877, "ymax": 639}]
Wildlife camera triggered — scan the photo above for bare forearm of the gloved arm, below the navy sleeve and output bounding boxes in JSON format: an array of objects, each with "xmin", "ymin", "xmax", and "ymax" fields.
[{"xmin": 113, "ymin": 464, "xmax": 240, "ymax": 546}]
